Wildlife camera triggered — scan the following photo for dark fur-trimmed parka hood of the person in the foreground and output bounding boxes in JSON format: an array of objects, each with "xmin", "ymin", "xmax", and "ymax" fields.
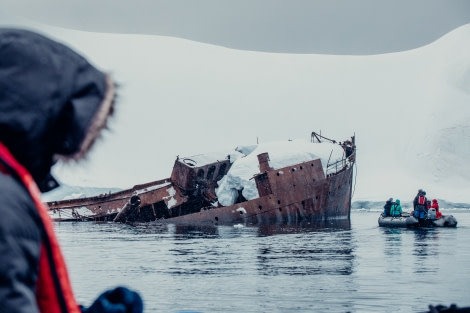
[{"xmin": 0, "ymin": 28, "xmax": 114, "ymax": 191}]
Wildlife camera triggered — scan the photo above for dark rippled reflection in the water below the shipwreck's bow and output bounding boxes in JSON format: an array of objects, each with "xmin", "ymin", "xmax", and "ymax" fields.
[{"xmin": 257, "ymin": 220, "xmax": 354, "ymax": 274}]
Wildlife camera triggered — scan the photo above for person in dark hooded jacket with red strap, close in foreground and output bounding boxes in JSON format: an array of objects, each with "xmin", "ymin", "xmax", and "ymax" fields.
[{"xmin": 0, "ymin": 28, "xmax": 143, "ymax": 313}]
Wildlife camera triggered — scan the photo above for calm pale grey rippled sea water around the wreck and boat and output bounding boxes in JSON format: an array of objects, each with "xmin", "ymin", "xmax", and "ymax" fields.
[{"xmin": 56, "ymin": 210, "xmax": 470, "ymax": 313}]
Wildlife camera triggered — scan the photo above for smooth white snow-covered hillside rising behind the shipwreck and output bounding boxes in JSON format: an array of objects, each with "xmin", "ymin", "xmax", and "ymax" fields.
[{"xmin": 5, "ymin": 20, "xmax": 470, "ymax": 203}]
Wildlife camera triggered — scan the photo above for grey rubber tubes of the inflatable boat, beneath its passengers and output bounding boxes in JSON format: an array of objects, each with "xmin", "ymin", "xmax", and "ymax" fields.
[{"xmin": 379, "ymin": 213, "xmax": 457, "ymax": 227}]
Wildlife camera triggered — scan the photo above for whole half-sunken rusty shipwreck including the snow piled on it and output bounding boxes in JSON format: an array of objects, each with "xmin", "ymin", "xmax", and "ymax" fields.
[{"xmin": 48, "ymin": 132, "xmax": 356, "ymax": 224}]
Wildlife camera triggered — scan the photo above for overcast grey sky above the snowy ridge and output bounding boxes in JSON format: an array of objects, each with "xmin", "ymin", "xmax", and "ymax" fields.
[{"xmin": 0, "ymin": 0, "xmax": 470, "ymax": 54}]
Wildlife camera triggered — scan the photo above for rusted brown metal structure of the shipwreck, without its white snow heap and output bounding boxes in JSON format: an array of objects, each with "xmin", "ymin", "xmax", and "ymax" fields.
[{"xmin": 47, "ymin": 132, "xmax": 356, "ymax": 224}]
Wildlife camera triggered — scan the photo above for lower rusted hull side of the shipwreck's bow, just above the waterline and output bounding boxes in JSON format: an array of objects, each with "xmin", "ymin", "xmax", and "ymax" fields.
[{"xmin": 161, "ymin": 168, "xmax": 353, "ymax": 225}]
